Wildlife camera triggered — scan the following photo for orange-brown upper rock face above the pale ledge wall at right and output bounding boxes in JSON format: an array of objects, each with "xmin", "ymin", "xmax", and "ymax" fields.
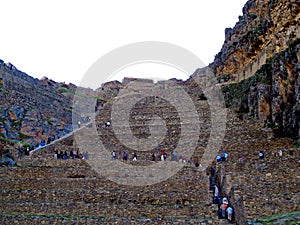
[{"xmin": 212, "ymin": 0, "xmax": 300, "ymax": 77}]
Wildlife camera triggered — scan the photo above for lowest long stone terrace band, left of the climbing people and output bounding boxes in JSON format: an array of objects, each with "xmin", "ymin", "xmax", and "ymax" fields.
[{"xmin": 1, "ymin": 202, "xmax": 215, "ymax": 219}]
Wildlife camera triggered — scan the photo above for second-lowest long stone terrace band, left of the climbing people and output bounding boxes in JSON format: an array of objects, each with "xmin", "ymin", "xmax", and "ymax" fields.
[{"xmin": 0, "ymin": 188, "xmax": 211, "ymax": 205}]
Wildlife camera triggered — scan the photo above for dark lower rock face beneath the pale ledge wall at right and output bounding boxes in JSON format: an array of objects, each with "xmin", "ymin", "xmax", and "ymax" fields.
[{"xmin": 222, "ymin": 39, "xmax": 300, "ymax": 138}]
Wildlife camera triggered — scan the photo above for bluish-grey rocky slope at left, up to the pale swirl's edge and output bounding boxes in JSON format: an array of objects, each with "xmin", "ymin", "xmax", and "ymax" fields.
[{"xmin": 0, "ymin": 60, "xmax": 76, "ymax": 149}]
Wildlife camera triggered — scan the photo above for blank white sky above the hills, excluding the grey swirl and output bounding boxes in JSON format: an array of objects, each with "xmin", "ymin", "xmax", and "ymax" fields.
[{"xmin": 0, "ymin": 0, "xmax": 246, "ymax": 88}]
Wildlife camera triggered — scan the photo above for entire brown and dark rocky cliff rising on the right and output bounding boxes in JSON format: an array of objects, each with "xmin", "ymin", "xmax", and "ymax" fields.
[{"xmin": 210, "ymin": 0, "xmax": 300, "ymax": 138}]
